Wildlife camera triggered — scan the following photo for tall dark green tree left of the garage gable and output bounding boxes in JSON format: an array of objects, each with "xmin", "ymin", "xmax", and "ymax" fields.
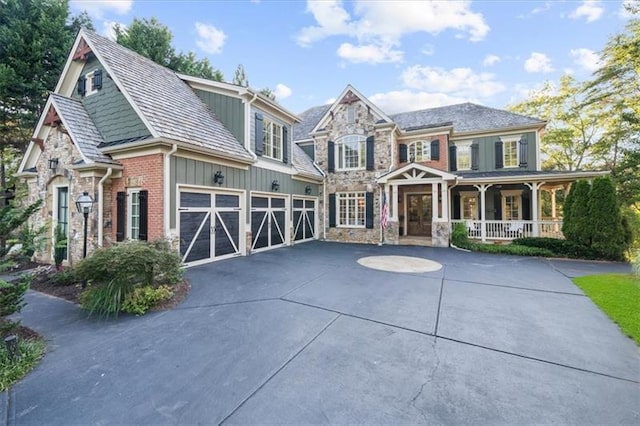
[{"xmin": 0, "ymin": 0, "xmax": 72, "ymax": 191}]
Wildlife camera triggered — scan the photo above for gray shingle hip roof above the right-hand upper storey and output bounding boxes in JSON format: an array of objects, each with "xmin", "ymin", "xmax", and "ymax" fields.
[{"xmin": 390, "ymin": 102, "xmax": 544, "ymax": 132}]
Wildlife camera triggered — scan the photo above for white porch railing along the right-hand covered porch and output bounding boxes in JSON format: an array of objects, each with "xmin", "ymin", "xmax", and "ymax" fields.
[{"xmin": 451, "ymin": 219, "xmax": 564, "ymax": 241}]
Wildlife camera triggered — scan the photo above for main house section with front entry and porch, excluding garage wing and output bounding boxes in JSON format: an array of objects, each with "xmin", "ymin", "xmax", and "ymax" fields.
[{"xmin": 294, "ymin": 86, "xmax": 603, "ymax": 247}]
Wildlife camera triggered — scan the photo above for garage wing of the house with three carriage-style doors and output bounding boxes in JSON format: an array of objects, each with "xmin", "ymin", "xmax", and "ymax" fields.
[{"xmin": 19, "ymin": 29, "xmax": 323, "ymax": 265}]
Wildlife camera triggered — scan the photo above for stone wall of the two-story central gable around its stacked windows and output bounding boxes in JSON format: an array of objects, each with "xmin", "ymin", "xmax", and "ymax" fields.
[{"xmin": 316, "ymin": 97, "xmax": 397, "ymax": 244}]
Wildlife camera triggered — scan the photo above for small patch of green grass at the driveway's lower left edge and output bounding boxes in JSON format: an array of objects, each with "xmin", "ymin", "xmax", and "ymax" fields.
[{"xmin": 0, "ymin": 339, "xmax": 45, "ymax": 392}]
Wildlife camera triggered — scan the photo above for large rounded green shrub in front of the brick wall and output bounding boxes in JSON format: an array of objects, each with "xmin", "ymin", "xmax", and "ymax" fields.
[{"xmin": 75, "ymin": 241, "xmax": 182, "ymax": 316}]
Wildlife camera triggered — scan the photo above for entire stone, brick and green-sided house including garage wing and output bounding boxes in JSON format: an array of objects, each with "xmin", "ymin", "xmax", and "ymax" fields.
[{"xmin": 18, "ymin": 29, "xmax": 598, "ymax": 265}]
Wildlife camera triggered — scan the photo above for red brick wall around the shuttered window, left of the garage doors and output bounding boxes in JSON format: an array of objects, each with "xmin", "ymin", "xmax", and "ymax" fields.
[{"xmin": 111, "ymin": 154, "xmax": 164, "ymax": 241}]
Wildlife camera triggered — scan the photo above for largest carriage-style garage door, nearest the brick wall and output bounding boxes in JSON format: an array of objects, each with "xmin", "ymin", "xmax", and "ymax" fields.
[{"xmin": 178, "ymin": 190, "xmax": 244, "ymax": 264}]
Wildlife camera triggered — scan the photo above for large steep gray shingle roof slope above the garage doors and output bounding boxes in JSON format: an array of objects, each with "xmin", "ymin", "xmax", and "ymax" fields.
[{"xmin": 83, "ymin": 30, "xmax": 253, "ymax": 160}]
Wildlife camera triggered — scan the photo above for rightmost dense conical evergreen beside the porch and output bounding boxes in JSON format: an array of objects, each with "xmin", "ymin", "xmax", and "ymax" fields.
[{"xmin": 584, "ymin": 176, "xmax": 629, "ymax": 260}]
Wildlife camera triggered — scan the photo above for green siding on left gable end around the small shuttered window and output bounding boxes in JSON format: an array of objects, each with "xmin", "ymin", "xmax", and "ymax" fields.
[{"xmin": 72, "ymin": 58, "xmax": 151, "ymax": 142}]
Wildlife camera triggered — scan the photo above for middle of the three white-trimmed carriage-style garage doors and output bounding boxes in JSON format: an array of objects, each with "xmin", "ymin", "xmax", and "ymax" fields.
[{"xmin": 251, "ymin": 195, "xmax": 289, "ymax": 251}]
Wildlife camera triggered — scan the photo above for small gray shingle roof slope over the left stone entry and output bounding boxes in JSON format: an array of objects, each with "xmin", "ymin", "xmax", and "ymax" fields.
[{"xmin": 51, "ymin": 93, "xmax": 119, "ymax": 164}]
